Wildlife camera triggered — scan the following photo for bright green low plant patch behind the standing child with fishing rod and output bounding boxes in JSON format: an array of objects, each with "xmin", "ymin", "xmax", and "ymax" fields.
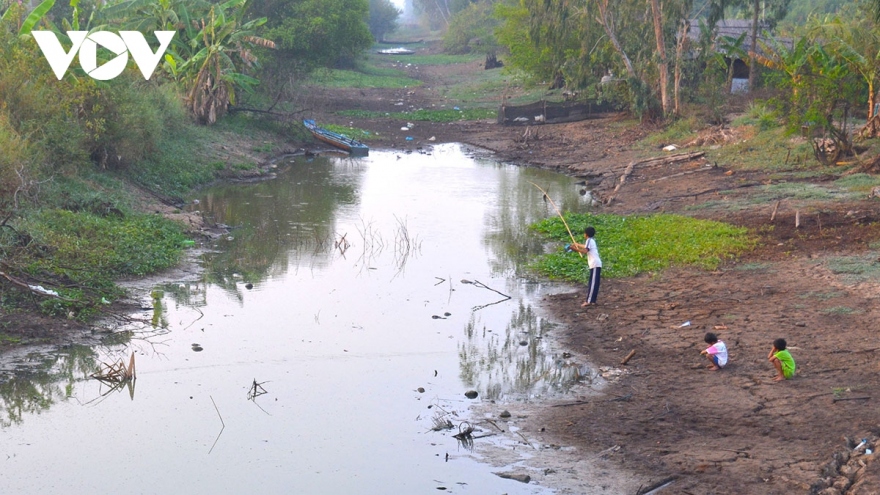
[{"xmin": 530, "ymin": 214, "xmax": 756, "ymax": 283}]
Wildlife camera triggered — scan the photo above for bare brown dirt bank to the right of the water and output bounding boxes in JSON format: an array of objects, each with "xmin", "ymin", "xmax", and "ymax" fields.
[{"xmin": 308, "ymin": 47, "xmax": 880, "ymax": 495}]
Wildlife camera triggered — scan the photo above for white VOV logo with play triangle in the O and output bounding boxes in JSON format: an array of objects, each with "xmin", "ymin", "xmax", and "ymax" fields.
[{"xmin": 31, "ymin": 31, "xmax": 175, "ymax": 81}]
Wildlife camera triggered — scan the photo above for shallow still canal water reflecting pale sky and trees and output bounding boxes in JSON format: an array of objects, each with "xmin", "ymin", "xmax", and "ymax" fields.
[{"xmin": 0, "ymin": 145, "xmax": 589, "ymax": 494}]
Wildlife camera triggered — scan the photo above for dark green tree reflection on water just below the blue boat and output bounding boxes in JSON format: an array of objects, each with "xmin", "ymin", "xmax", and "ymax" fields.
[{"xmin": 198, "ymin": 157, "xmax": 362, "ymax": 299}]
